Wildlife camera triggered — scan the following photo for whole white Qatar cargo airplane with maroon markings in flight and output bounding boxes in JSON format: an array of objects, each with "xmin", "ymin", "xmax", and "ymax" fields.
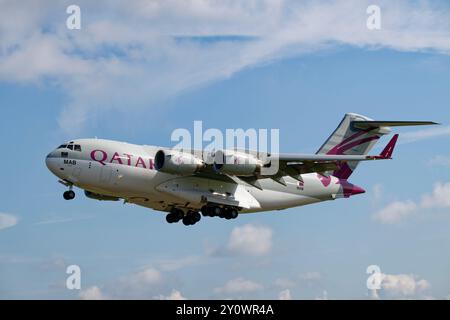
[{"xmin": 46, "ymin": 113, "xmax": 436, "ymax": 225}]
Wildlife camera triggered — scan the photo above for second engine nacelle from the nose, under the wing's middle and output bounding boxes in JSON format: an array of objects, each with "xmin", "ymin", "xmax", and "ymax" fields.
[{"xmin": 213, "ymin": 150, "xmax": 262, "ymax": 176}]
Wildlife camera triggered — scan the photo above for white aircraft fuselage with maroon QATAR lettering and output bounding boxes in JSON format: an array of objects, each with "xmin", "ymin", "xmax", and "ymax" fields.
[{"xmin": 46, "ymin": 139, "xmax": 364, "ymax": 220}]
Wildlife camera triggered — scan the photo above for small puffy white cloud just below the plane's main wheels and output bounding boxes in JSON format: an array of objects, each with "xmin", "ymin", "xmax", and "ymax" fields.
[{"xmin": 227, "ymin": 224, "xmax": 272, "ymax": 256}]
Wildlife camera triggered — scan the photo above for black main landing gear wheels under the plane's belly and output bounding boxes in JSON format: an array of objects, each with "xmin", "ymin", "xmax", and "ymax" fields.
[{"xmin": 166, "ymin": 205, "xmax": 239, "ymax": 226}]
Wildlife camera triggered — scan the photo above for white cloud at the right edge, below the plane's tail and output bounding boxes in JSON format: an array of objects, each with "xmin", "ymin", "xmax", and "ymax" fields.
[{"xmin": 373, "ymin": 182, "xmax": 450, "ymax": 224}]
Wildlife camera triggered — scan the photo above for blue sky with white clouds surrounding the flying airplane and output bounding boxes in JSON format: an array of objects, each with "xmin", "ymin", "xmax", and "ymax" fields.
[{"xmin": 0, "ymin": 0, "xmax": 450, "ymax": 299}]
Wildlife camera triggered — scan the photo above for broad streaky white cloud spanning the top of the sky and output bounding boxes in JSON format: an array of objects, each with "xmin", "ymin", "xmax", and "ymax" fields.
[{"xmin": 0, "ymin": 0, "xmax": 450, "ymax": 132}]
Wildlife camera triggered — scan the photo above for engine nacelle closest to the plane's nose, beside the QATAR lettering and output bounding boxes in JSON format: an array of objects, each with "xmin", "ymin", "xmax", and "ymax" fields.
[{"xmin": 155, "ymin": 150, "xmax": 205, "ymax": 175}]
